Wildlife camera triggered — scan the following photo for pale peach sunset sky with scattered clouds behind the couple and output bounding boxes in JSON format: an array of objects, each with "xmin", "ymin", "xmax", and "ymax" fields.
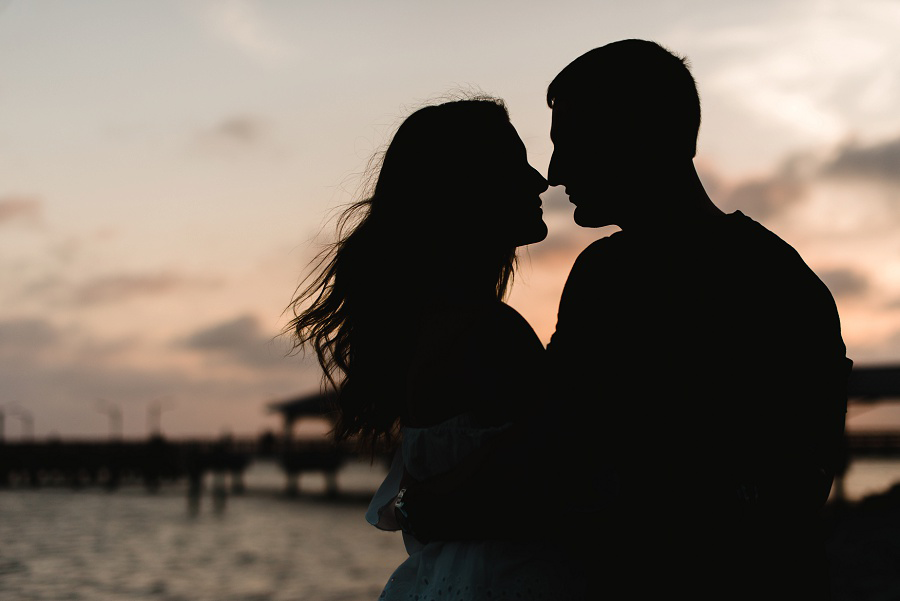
[{"xmin": 0, "ymin": 0, "xmax": 900, "ymax": 439}]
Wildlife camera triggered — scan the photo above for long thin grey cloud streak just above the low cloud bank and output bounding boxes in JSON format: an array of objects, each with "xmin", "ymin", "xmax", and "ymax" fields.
[{"xmin": 72, "ymin": 273, "xmax": 216, "ymax": 305}]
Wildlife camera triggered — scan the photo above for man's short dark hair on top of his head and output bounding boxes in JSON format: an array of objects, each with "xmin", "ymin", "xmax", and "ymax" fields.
[{"xmin": 547, "ymin": 40, "xmax": 700, "ymax": 157}]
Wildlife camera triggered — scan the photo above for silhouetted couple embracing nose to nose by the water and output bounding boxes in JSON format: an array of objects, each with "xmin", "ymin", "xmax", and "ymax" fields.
[{"xmin": 292, "ymin": 40, "xmax": 850, "ymax": 600}]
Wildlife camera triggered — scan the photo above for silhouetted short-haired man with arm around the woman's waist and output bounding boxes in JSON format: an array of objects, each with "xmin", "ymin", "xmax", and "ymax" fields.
[{"xmin": 396, "ymin": 40, "xmax": 851, "ymax": 599}]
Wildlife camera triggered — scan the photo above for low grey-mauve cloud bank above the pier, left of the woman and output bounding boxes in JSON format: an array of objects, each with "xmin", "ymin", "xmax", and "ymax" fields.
[{"xmin": 0, "ymin": 317, "xmax": 320, "ymax": 437}]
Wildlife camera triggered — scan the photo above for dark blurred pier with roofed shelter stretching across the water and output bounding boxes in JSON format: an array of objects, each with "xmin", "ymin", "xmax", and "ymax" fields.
[{"xmin": 0, "ymin": 365, "xmax": 900, "ymax": 498}]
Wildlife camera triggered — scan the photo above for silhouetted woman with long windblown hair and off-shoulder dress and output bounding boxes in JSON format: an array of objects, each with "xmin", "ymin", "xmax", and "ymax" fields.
[{"xmin": 289, "ymin": 97, "xmax": 580, "ymax": 600}]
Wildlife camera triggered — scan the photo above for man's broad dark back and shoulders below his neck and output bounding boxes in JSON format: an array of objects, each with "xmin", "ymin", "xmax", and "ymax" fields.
[{"xmin": 549, "ymin": 213, "xmax": 849, "ymax": 596}]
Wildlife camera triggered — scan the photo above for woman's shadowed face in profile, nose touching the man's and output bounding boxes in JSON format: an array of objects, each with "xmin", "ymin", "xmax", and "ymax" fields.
[{"xmin": 466, "ymin": 122, "xmax": 547, "ymax": 246}]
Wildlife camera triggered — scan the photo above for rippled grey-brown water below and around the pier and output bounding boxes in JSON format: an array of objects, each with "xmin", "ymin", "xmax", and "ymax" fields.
[{"xmin": 0, "ymin": 461, "xmax": 900, "ymax": 601}]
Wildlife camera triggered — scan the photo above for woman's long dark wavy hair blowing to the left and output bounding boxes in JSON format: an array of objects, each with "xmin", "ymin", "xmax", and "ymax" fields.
[{"xmin": 285, "ymin": 97, "xmax": 516, "ymax": 450}]
